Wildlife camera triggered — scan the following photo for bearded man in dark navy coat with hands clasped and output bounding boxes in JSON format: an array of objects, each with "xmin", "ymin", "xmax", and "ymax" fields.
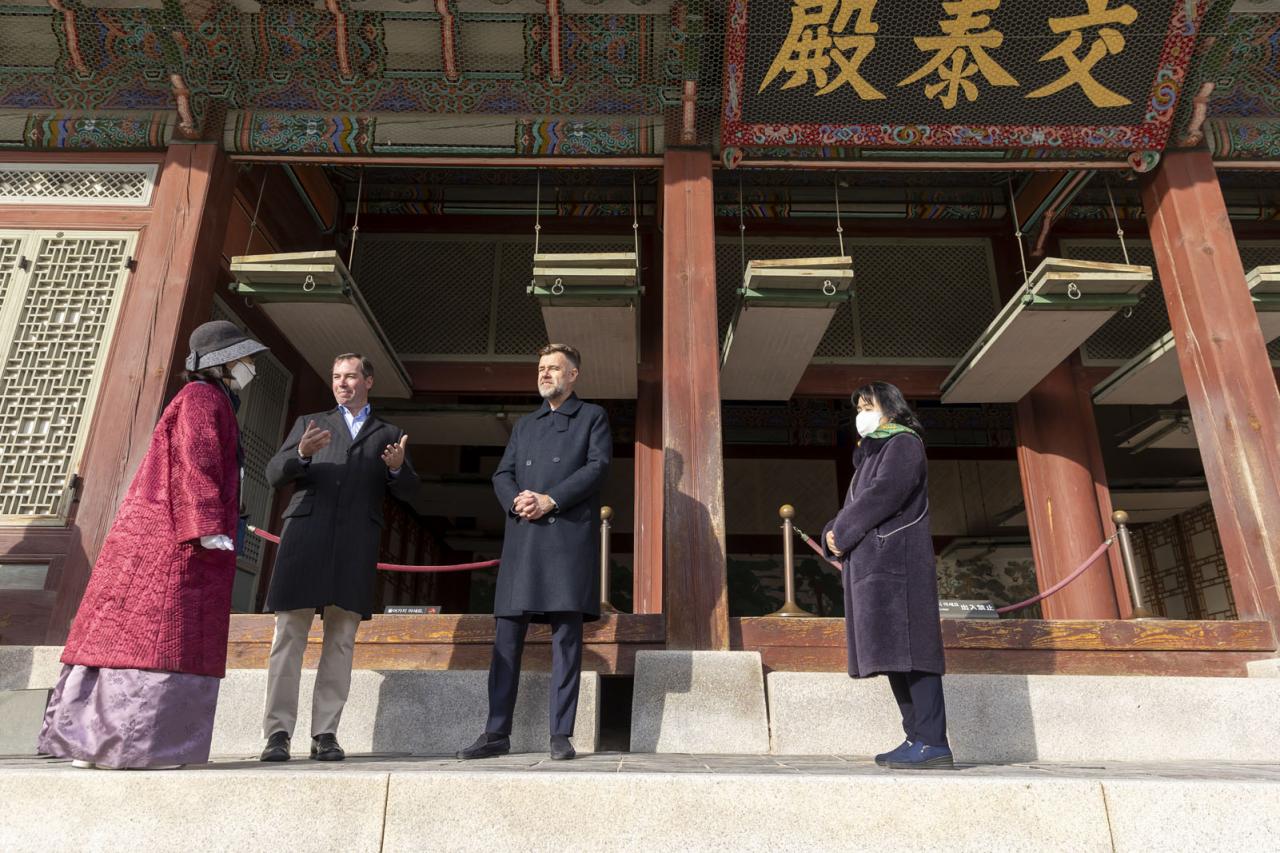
[{"xmin": 458, "ymin": 343, "xmax": 613, "ymax": 760}]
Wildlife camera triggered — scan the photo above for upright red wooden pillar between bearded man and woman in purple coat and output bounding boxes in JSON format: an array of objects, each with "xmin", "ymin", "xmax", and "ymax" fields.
[{"xmin": 662, "ymin": 150, "xmax": 728, "ymax": 649}]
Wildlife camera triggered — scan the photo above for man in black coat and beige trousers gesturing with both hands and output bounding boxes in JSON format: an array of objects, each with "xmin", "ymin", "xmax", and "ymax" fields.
[{"xmin": 254, "ymin": 352, "xmax": 419, "ymax": 761}]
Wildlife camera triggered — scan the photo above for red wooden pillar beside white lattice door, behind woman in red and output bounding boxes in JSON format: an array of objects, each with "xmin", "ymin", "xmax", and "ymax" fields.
[{"xmin": 47, "ymin": 143, "xmax": 236, "ymax": 644}]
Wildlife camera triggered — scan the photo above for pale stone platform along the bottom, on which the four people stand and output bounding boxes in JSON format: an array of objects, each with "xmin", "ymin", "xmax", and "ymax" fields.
[{"xmin": 0, "ymin": 753, "xmax": 1280, "ymax": 853}]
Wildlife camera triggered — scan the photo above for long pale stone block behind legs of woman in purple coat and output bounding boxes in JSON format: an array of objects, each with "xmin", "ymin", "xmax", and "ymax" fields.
[{"xmin": 769, "ymin": 672, "xmax": 1280, "ymax": 763}]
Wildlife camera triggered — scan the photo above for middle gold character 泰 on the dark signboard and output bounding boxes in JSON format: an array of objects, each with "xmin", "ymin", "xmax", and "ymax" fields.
[{"xmin": 899, "ymin": 0, "xmax": 1018, "ymax": 110}]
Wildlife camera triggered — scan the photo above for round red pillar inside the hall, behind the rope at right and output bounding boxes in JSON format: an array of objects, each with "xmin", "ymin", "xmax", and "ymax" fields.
[{"xmin": 1016, "ymin": 361, "xmax": 1129, "ymax": 619}]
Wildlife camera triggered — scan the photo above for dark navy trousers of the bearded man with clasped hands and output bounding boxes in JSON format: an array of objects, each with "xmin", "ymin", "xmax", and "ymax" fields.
[{"xmin": 484, "ymin": 612, "xmax": 582, "ymax": 736}]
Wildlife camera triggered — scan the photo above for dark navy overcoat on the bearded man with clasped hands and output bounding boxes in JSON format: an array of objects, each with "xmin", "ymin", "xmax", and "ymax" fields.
[{"xmin": 493, "ymin": 394, "xmax": 613, "ymax": 621}]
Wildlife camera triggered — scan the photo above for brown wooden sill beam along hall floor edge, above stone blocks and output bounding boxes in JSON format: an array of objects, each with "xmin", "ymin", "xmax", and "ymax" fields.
[{"xmin": 227, "ymin": 613, "xmax": 1276, "ymax": 676}]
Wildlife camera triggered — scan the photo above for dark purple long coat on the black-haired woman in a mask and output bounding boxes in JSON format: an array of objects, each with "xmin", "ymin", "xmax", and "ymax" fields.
[{"xmin": 822, "ymin": 432, "xmax": 945, "ymax": 678}]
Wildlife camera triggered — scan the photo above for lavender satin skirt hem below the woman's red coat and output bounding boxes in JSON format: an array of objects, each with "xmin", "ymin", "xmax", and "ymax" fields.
[{"xmin": 36, "ymin": 665, "xmax": 220, "ymax": 768}]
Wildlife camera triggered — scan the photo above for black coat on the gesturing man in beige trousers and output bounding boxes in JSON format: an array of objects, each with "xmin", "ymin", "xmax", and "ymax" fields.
[{"xmin": 266, "ymin": 409, "xmax": 419, "ymax": 619}]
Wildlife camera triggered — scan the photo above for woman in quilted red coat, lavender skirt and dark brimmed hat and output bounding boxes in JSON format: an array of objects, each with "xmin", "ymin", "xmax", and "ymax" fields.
[{"xmin": 37, "ymin": 320, "xmax": 266, "ymax": 770}]
